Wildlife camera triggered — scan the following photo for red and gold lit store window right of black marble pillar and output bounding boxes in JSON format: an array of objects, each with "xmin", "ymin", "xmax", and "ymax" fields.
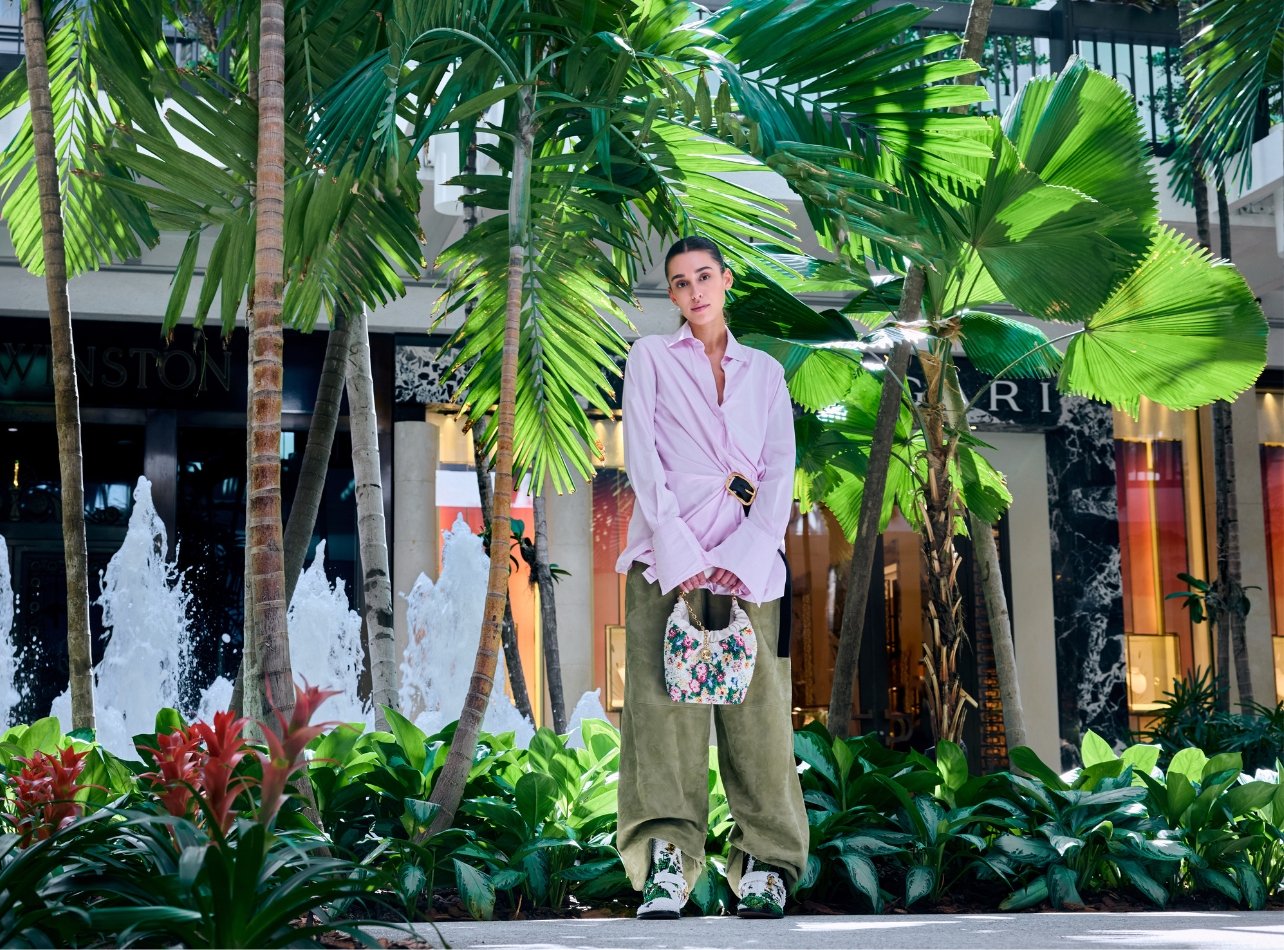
[{"xmin": 1115, "ymin": 401, "xmax": 1207, "ymax": 729}]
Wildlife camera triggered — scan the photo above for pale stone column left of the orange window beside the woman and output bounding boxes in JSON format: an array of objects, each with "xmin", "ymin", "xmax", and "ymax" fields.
[{"xmin": 541, "ymin": 483, "xmax": 594, "ymax": 721}]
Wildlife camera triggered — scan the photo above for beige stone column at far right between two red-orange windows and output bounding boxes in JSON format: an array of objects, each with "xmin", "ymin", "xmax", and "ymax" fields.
[{"xmin": 1230, "ymin": 389, "xmax": 1278, "ymax": 709}]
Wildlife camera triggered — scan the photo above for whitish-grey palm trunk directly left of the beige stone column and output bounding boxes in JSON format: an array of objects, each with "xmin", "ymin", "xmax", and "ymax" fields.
[{"xmin": 347, "ymin": 308, "xmax": 397, "ymax": 729}]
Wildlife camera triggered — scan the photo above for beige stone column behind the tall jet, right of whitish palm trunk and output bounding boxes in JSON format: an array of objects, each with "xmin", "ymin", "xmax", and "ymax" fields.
[{"xmin": 392, "ymin": 420, "xmax": 442, "ymax": 688}]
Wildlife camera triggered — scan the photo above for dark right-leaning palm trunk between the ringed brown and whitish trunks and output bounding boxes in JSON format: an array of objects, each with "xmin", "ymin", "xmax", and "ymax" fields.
[{"xmin": 284, "ymin": 311, "xmax": 352, "ymax": 605}]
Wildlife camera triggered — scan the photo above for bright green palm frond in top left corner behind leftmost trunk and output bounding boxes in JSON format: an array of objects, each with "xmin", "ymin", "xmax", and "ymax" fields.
[{"xmin": 0, "ymin": 0, "xmax": 168, "ymax": 276}]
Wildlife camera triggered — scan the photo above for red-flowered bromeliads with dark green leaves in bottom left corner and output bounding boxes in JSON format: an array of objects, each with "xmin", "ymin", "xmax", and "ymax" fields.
[{"xmin": 0, "ymin": 686, "xmax": 398, "ymax": 947}]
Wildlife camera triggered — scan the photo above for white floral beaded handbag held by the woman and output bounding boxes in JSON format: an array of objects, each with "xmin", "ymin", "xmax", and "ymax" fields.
[{"xmin": 664, "ymin": 594, "xmax": 758, "ymax": 705}]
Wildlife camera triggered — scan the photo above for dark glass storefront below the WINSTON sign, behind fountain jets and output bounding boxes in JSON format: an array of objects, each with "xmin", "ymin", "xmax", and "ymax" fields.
[{"xmin": 0, "ymin": 317, "xmax": 392, "ymax": 718}]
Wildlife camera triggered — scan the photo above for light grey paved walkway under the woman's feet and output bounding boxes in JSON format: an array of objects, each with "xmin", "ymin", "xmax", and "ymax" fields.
[{"xmin": 372, "ymin": 911, "xmax": 1284, "ymax": 950}]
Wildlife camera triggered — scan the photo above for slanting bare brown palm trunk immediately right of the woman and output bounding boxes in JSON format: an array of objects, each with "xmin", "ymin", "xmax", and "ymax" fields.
[{"xmin": 828, "ymin": 267, "xmax": 924, "ymax": 738}]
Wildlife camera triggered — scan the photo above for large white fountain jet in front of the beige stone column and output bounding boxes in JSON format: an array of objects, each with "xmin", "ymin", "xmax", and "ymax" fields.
[{"xmin": 397, "ymin": 516, "xmax": 535, "ymax": 748}]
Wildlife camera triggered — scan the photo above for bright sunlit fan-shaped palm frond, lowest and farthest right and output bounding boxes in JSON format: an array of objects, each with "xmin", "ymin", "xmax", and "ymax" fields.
[{"xmin": 1058, "ymin": 227, "xmax": 1267, "ymax": 416}]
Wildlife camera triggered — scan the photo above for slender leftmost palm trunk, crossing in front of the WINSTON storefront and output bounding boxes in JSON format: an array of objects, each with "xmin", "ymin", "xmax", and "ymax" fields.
[{"xmin": 22, "ymin": 0, "xmax": 94, "ymax": 729}]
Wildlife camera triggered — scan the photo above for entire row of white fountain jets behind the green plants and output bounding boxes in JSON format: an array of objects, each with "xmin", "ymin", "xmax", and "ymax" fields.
[{"xmin": 20, "ymin": 478, "xmax": 606, "ymax": 757}]
